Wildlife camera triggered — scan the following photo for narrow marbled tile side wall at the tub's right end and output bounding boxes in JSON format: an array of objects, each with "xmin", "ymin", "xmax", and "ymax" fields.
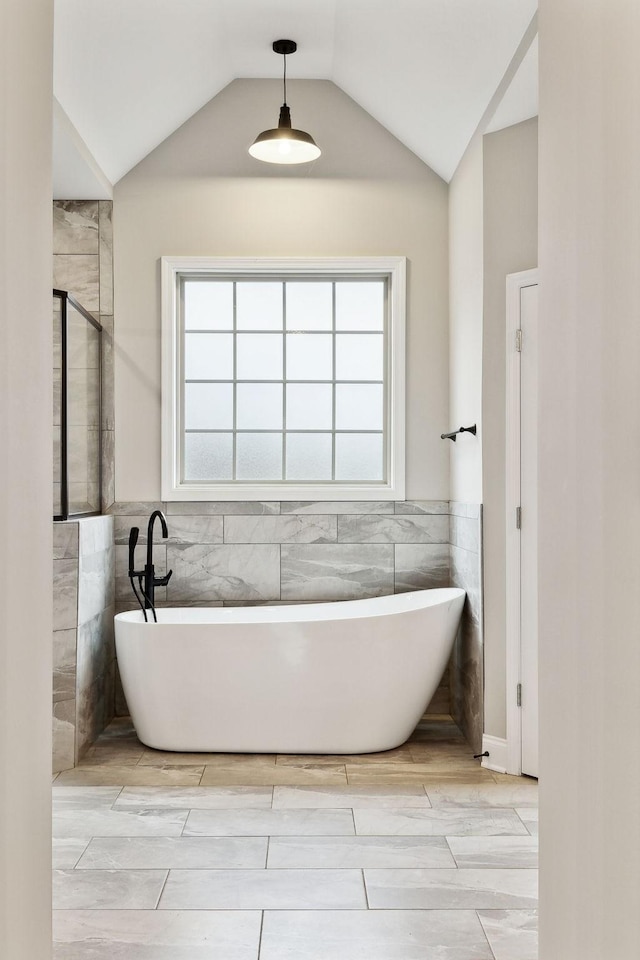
[{"xmin": 449, "ymin": 501, "xmax": 484, "ymax": 753}]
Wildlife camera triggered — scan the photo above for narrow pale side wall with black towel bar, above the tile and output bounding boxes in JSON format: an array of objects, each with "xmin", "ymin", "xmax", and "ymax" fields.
[{"xmin": 448, "ymin": 137, "xmax": 483, "ymax": 503}]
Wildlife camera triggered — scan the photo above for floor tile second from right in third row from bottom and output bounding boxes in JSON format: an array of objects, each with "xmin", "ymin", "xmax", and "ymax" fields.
[{"xmin": 267, "ymin": 837, "xmax": 456, "ymax": 870}]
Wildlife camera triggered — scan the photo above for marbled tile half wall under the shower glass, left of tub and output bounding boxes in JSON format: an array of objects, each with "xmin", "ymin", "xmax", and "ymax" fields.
[{"xmin": 53, "ymin": 516, "xmax": 115, "ymax": 772}]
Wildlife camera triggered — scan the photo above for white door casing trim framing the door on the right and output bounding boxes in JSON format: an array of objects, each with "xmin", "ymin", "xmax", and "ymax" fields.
[{"xmin": 505, "ymin": 268, "xmax": 538, "ymax": 776}]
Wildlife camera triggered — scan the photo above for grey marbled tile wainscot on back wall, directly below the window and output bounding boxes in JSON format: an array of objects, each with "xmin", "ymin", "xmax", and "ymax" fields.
[{"xmin": 111, "ymin": 500, "xmax": 451, "ymax": 713}]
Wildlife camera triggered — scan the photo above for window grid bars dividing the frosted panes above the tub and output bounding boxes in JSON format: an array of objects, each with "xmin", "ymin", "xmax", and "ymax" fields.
[{"xmin": 179, "ymin": 273, "xmax": 389, "ymax": 487}]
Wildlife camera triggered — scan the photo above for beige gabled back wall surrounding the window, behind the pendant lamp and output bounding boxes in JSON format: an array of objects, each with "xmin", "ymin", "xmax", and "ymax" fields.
[{"xmin": 114, "ymin": 80, "xmax": 449, "ymax": 501}]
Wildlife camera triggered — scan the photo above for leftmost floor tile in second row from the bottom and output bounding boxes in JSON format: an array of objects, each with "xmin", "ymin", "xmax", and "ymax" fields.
[{"xmin": 53, "ymin": 870, "xmax": 167, "ymax": 910}]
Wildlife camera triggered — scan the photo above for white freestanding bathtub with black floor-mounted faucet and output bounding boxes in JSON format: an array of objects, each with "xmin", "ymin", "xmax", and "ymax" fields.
[{"xmin": 115, "ymin": 589, "xmax": 465, "ymax": 753}]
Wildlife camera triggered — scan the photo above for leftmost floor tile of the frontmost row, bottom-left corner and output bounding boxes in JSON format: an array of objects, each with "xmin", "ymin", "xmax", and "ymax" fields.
[{"xmin": 53, "ymin": 910, "xmax": 262, "ymax": 960}]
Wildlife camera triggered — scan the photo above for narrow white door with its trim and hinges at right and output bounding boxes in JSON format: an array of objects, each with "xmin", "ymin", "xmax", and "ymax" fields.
[{"xmin": 505, "ymin": 270, "xmax": 538, "ymax": 777}]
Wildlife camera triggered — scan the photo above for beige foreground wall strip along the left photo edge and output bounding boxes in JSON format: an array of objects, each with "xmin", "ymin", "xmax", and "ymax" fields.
[{"xmin": 0, "ymin": 0, "xmax": 53, "ymax": 960}]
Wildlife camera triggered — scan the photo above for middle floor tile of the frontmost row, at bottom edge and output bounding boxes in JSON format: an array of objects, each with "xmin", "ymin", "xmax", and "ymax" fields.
[{"xmin": 260, "ymin": 910, "xmax": 493, "ymax": 960}]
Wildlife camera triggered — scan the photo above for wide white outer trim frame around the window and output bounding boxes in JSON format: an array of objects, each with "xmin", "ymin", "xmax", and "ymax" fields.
[{"xmin": 160, "ymin": 257, "xmax": 406, "ymax": 501}]
